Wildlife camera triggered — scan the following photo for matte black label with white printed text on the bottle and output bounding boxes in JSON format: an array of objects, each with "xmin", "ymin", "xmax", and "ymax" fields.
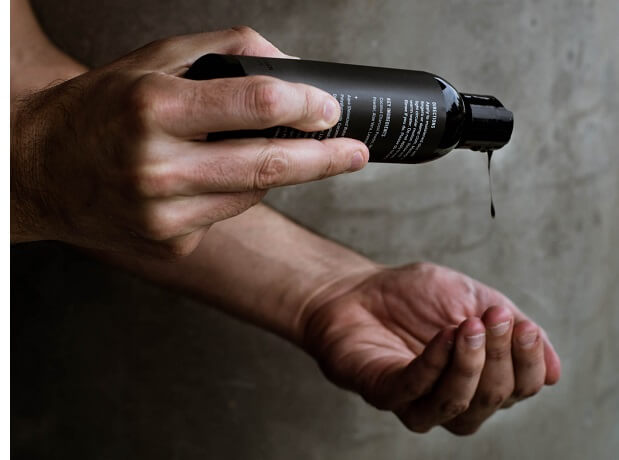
[{"xmin": 241, "ymin": 57, "xmax": 446, "ymax": 163}]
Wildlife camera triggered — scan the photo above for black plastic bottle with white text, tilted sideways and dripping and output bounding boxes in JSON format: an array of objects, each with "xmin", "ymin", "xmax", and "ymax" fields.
[{"xmin": 185, "ymin": 54, "xmax": 513, "ymax": 163}]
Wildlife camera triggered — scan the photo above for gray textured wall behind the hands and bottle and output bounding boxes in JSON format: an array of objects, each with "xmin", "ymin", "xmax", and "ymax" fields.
[{"xmin": 11, "ymin": 0, "xmax": 619, "ymax": 460}]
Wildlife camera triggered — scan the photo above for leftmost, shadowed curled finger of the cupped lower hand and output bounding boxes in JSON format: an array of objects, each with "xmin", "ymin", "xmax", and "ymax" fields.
[{"xmin": 366, "ymin": 327, "xmax": 456, "ymax": 410}]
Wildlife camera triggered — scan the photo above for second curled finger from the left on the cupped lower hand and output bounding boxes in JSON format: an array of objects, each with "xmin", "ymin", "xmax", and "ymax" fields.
[{"xmin": 397, "ymin": 318, "xmax": 486, "ymax": 432}]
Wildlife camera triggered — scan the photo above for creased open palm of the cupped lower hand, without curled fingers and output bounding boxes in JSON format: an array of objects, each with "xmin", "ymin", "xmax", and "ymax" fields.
[{"xmin": 306, "ymin": 264, "xmax": 524, "ymax": 406}]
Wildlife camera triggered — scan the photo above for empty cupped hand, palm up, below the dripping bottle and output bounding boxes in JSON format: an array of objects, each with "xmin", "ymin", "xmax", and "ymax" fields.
[{"xmin": 302, "ymin": 263, "xmax": 560, "ymax": 434}]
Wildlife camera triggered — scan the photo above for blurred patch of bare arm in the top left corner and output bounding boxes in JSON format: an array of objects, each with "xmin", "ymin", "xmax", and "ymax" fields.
[{"xmin": 11, "ymin": 0, "xmax": 87, "ymax": 99}]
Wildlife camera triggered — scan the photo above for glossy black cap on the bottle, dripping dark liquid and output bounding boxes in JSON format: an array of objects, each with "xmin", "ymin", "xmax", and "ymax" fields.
[{"xmin": 456, "ymin": 93, "xmax": 514, "ymax": 151}]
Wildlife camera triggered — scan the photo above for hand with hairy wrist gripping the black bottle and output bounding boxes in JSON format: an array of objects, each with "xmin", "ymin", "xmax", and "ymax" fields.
[{"xmin": 11, "ymin": 28, "xmax": 368, "ymax": 257}]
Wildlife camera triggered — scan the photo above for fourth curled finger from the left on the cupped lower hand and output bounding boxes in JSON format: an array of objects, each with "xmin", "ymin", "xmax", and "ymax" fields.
[{"xmin": 508, "ymin": 321, "xmax": 546, "ymax": 405}]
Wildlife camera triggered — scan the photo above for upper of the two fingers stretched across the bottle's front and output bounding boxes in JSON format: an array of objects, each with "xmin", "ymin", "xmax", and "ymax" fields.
[{"xmin": 151, "ymin": 75, "xmax": 340, "ymax": 139}]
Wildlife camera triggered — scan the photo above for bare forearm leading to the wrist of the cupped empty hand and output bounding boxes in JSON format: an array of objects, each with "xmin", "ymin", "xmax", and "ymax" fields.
[{"xmin": 102, "ymin": 205, "xmax": 376, "ymax": 342}]
